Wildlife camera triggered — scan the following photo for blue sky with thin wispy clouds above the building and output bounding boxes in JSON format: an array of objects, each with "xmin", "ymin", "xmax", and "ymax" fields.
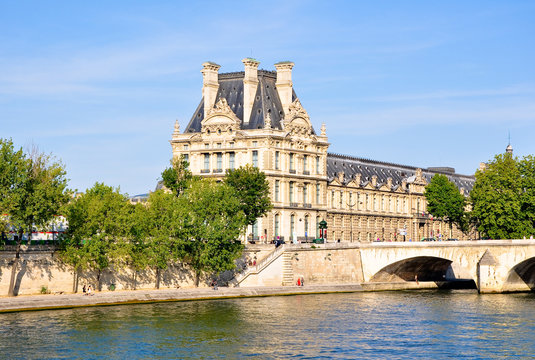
[{"xmin": 0, "ymin": 0, "xmax": 535, "ymax": 195}]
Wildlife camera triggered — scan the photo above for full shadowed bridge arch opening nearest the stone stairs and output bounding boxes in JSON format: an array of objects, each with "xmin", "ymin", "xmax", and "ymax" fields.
[{"xmin": 370, "ymin": 256, "xmax": 475, "ymax": 287}]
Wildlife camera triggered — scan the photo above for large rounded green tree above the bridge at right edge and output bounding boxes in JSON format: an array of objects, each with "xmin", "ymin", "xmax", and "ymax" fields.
[{"xmin": 470, "ymin": 153, "xmax": 535, "ymax": 239}]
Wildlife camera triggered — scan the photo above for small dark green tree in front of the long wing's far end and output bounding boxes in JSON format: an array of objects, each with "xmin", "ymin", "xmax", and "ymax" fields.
[{"xmin": 424, "ymin": 174, "xmax": 468, "ymax": 237}]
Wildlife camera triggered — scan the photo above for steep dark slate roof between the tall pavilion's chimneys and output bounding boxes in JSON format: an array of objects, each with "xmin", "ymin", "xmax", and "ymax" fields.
[{"xmin": 184, "ymin": 70, "xmax": 306, "ymax": 133}]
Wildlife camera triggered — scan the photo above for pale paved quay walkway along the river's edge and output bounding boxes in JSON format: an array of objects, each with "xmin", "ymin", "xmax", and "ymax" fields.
[{"xmin": 0, "ymin": 284, "xmax": 363, "ymax": 313}]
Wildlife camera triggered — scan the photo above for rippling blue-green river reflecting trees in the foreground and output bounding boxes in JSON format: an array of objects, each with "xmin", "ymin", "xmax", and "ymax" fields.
[{"xmin": 0, "ymin": 290, "xmax": 535, "ymax": 359}]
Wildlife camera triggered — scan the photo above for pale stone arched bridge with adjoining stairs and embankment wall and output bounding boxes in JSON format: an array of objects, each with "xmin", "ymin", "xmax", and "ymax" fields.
[{"xmin": 241, "ymin": 240, "xmax": 535, "ymax": 293}]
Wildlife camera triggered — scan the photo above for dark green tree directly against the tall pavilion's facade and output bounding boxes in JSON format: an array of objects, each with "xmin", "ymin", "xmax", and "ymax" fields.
[{"xmin": 225, "ymin": 164, "xmax": 272, "ymax": 225}]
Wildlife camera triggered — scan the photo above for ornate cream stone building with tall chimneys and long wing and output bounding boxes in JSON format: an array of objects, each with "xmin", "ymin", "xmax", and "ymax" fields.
[{"xmin": 171, "ymin": 58, "xmax": 474, "ymax": 242}]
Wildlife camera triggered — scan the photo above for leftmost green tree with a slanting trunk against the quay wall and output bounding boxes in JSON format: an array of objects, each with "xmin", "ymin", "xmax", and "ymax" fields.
[{"xmin": 0, "ymin": 139, "xmax": 69, "ymax": 296}]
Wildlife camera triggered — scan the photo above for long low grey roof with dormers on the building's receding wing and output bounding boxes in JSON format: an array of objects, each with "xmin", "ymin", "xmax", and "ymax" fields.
[{"xmin": 327, "ymin": 153, "xmax": 475, "ymax": 193}]
